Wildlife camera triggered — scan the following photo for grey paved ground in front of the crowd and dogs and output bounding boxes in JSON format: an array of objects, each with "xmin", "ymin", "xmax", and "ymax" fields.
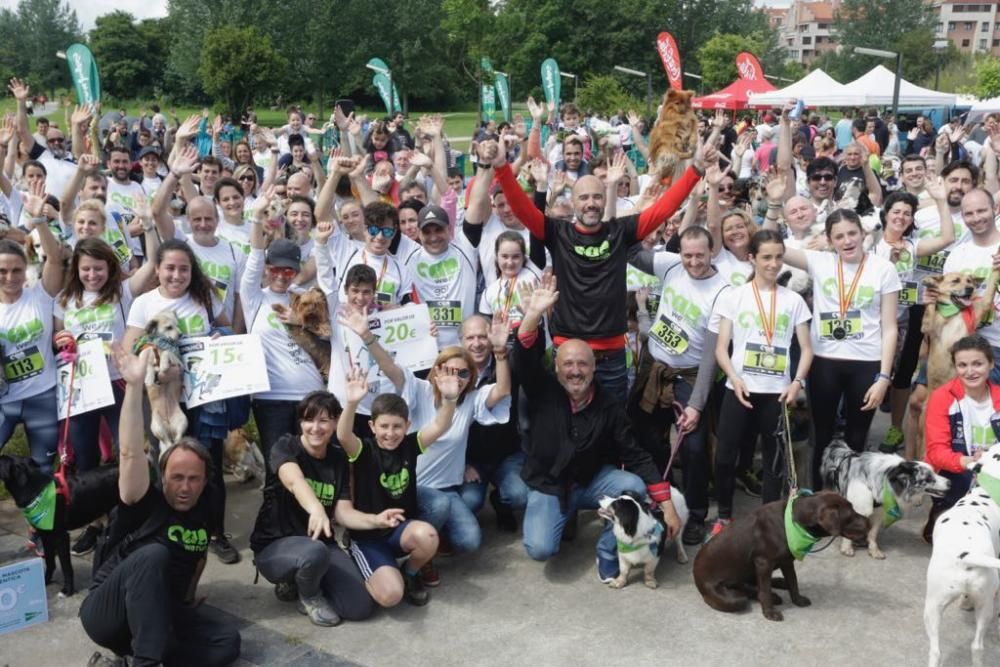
[{"xmin": 0, "ymin": 415, "xmax": 1000, "ymax": 667}]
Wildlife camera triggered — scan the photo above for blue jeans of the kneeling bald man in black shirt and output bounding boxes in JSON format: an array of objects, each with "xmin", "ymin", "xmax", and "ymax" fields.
[{"xmin": 523, "ymin": 465, "xmax": 646, "ymax": 570}]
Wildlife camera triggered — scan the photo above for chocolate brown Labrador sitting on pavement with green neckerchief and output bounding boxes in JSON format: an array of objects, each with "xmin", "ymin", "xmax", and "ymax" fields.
[{"xmin": 694, "ymin": 493, "xmax": 868, "ymax": 621}]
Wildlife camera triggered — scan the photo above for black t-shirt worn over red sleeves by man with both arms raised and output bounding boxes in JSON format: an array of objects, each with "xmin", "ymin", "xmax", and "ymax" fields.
[{"xmin": 545, "ymin": 215, "xmax": 640, "ymax": 340}]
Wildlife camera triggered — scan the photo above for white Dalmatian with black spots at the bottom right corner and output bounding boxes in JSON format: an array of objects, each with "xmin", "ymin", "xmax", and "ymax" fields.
[{"xmin": 924, "ymin": 445, "xmax": 1000, "ymax": 667}]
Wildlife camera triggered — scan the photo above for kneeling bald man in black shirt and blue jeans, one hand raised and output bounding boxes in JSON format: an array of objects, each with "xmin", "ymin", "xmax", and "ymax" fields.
[{"xmin": 514, "ymin": 275, "xmax": 681, "ymax": 583}]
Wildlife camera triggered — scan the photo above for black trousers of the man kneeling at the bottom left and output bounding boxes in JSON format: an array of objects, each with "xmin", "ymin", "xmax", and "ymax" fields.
[{"xmin": 80, "ymin": 543, "xmax": 240, "ymax": 666}]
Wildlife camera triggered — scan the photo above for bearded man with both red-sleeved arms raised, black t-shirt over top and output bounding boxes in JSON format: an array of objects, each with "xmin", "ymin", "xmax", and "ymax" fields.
[{"xmin": 493, "ymin": 134, "xmax": 717, "ymax": 402}]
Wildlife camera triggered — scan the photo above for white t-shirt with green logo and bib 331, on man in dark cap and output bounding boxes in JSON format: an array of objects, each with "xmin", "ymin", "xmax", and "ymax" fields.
[{"xmin": 403, "ymin": 232, "xmax": 479, "ymax": 349}]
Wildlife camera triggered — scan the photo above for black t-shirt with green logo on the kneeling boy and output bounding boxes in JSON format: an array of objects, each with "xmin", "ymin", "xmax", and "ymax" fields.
[{"xmin": 351, "ymin": 433, "xmax": 421, "ymax": 540}]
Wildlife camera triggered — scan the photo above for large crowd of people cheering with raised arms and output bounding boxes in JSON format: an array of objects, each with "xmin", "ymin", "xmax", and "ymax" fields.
[{"xmin": 0, "ymin": 70, "xmax": 1000, "ymax": 665}]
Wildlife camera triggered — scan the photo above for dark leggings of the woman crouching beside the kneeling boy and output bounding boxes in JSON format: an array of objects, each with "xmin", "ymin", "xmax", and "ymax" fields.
[{"xmin": 254, "ymin": 535, "xmax": 375, "ymax": 621}]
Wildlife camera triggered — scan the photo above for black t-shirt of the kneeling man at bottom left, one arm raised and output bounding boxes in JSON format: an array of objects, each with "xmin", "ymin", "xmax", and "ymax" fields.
[{"xmin": 91, "ymin": 485, "xmax": 209, "ymax": 600}]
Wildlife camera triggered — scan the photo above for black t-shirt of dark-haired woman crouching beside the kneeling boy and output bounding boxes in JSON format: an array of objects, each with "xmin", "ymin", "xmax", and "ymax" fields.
[{"xmin": 250, "ymin": 435, "xmax": 350, "ymax": 552}]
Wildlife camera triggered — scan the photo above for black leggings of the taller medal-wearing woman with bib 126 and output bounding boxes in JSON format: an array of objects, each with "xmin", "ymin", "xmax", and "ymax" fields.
[{"xmin": 809, "ymin": 357, "xmax": 881, "ymax": 491}]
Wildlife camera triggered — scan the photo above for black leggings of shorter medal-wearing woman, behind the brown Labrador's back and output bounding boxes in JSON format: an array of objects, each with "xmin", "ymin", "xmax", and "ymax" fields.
[{"xmin": 715, "ymin": 389, "xmax": 785, "ymax": 519}]
